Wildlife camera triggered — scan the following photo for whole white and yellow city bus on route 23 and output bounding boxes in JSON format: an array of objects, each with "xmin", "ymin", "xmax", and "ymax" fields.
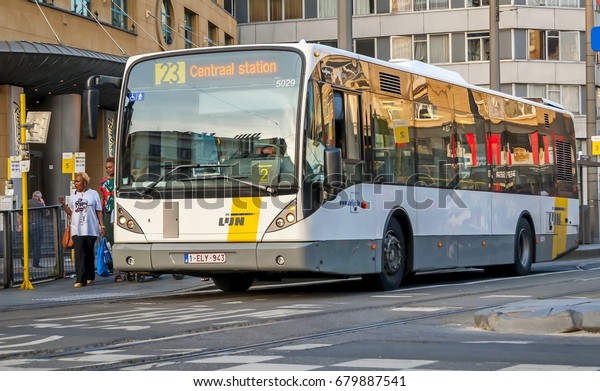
[{"xmin": 84, "ymin": 42, "xmax": 579, "ymax": 291}]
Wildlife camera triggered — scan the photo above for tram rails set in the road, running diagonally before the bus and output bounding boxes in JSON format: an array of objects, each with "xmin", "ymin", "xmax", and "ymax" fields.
[{"xmin": 5, "ymin": 265, "xmax": 598, "ymax": 370}]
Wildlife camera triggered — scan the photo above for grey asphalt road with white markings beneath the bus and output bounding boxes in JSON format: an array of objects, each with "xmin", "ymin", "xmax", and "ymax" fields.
[{"xmin": 0, "ymin": 254, "xmax": 600, "ymax": 371}]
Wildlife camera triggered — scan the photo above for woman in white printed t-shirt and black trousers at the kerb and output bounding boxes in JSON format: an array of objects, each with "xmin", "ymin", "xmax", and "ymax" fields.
[{"xmin": 58, "ymin": 172, "xmax": 104, "ymax": 288}]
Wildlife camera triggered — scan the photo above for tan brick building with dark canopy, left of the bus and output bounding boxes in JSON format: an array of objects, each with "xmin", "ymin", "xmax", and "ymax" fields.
[{"xmin": 0, "ymin": 0, "xmax": 238, "ymax": 207}]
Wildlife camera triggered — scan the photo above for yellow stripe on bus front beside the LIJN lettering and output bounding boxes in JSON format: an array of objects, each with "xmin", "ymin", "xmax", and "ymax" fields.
[{"xmin": 227, "ymin": 197, "xmax": 261, "ymax": 242}]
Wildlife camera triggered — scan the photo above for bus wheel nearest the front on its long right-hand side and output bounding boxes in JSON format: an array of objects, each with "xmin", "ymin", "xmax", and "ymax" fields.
[{"xmin": 363, "ymin": 219, "xmax": 406, "ymax": 291}]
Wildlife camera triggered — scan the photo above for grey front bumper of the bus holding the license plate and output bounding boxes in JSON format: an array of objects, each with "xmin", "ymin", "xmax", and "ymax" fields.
[{"xmin": 112, "ymin": 240, "xmax": 381, "ymax": 276}]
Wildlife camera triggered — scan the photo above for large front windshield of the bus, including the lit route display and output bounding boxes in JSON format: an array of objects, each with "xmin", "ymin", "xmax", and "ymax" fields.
[{"xmin": 117, "ymin": 49, "xmax": 303, "ymax": 197}]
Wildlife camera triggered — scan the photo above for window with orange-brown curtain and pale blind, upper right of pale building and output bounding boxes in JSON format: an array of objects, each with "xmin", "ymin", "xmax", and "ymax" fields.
[{"xmin": 529, "ymin": 30, "xmax": 580, "ymax": 61}]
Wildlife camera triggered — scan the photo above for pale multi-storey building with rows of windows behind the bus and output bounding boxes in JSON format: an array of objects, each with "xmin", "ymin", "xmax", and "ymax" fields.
[{"xmin": 233, "ymin": 0, "xmax": 600, "ymax": 240}]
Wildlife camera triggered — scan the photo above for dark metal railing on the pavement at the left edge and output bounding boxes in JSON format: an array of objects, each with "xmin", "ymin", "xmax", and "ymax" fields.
[{"xmin": 0, "ymin": 206, "xmax": 75, "ymax": 288}]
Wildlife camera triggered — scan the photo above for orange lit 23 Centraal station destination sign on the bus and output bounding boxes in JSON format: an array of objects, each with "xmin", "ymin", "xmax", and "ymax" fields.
[{"xmin": 154, "ymin": 60, "xmax": 279, "ymax": 85}]
